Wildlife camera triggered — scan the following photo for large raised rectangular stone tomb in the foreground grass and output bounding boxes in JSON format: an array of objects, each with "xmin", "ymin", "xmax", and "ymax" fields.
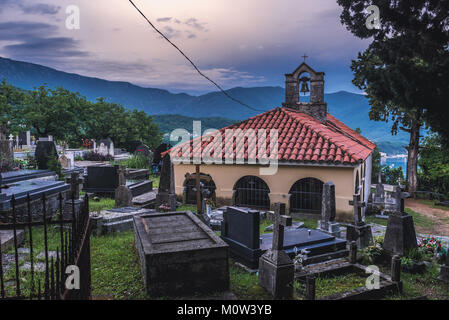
[{"xmin": 133, "ymin": 211, "xmax": 229, "ymax": 298}]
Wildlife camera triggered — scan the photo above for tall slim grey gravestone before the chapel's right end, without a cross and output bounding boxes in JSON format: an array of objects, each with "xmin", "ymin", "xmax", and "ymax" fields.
[{"xmin": 318, "ymin": 182, "xmax": 341, "ymax": 238}]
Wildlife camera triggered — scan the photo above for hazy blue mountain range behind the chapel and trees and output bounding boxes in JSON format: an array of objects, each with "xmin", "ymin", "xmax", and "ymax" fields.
[{"xmin": 0, "ymin": 57, "xmax": 408, "ymax": 153}]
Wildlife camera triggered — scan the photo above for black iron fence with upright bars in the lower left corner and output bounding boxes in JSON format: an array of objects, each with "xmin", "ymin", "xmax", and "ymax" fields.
[{"xmin": 0, "ymin": 193, "xmax": 91, "ymax": 300}]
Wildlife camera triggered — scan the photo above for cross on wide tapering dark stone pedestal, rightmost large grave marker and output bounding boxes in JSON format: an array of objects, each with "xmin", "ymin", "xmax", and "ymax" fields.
[{"xmin": 383, "ymin": 186, "xmax": 418, "ymax": 255}]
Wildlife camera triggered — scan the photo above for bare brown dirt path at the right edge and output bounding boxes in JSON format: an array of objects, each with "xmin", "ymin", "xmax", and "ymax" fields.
[{"xmin": 405, "ymin": 199, "xmax": 449, "ymax": 236}]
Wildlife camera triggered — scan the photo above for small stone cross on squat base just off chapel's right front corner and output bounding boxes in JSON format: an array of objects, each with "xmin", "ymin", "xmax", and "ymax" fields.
[{"xmin": 346, "ymin": 194, "xmax": 373, "ymax": 249}]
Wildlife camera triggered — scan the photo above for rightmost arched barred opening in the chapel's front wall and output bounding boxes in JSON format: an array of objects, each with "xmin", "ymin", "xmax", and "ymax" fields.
[{"xmin": 289, "ymin": 178, "xmax": 323, "ymax": 214}]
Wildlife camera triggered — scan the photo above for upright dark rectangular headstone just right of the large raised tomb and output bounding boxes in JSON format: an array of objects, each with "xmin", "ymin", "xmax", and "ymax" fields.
[{"xmin": 221, "ymin": 207, "xmax": 262, "ymax": 269}]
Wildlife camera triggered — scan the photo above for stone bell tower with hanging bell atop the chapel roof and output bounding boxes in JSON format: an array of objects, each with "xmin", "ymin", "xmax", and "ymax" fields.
[{"xmin": 282, "ymin": 62, "xmax": 327, "ymax": 123}]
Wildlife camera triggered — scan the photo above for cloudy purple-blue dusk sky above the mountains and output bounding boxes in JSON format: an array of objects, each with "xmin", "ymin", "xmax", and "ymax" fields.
[{"xmin": 0, "ymin": 0, "xmax": 368, "ymax": 93}]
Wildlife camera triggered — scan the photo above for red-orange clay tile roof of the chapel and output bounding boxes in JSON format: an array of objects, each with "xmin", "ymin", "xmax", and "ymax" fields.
[{"xmin": 168, "ymin": 108, "xmax": 376, "ymax": 165}]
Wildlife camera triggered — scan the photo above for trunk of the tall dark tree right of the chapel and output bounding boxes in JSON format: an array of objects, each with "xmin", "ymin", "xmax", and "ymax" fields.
[{"xmin": 407, "ymin": 112, "xmax": 421, "ymax": 197}]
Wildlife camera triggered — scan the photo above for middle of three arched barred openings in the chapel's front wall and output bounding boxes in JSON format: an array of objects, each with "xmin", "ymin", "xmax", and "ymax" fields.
[{"xmin": 233, "ymin": 176, "xmax": 270, "ymax": 209}]
